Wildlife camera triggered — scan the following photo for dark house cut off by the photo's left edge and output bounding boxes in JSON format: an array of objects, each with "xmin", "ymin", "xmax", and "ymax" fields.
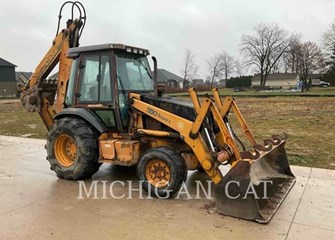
[{"xmin": 0, "ymin": 58, "xmax": 16, "ymax": 97}]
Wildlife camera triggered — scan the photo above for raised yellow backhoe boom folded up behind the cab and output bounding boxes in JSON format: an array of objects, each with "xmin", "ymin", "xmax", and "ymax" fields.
[{"xmin": 18, "ymin": 2, "xmax": 86, "ymax": 130}]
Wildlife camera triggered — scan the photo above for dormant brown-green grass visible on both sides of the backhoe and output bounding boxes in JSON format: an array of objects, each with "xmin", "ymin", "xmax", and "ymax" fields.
[{"xmin": 0, "ymin": 95, "xmax": 335, "ymax": 169}]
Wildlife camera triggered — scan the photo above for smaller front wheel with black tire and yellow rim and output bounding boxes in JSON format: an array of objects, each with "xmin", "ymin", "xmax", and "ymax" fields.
[{"xmin": 137, "ymin": 147, "xmax": 187, "ymax": 198}]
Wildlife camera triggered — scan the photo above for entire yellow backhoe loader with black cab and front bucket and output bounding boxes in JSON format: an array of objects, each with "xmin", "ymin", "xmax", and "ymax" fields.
[{"xmin": 19, "ymin": 1, "xmax": 295, "ymax": 223}]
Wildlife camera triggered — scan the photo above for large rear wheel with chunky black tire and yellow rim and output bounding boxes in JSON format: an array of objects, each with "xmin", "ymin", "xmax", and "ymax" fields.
[{"xmin": 46, "ymin": 117, "xmax": 101, "ymax": 180}]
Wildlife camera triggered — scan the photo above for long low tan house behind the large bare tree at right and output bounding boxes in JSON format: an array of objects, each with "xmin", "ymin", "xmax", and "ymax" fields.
[{"xmin": 251, "ymin": 73, "xmax": 300, "ymax": 89}]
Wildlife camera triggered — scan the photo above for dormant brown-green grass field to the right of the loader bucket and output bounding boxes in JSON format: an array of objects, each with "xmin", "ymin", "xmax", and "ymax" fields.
[{"xmin": 228, "ymin": 97, "xmax": 335, "ymax": 169}]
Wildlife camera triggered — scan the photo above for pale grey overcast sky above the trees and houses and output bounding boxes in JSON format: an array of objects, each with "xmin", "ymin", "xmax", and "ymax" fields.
[{"xmin": 0, "ymin": 0, "xmax": 335, "ymax": 79}]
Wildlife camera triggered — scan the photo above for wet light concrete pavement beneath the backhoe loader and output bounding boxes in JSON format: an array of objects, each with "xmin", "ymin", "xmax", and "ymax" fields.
[{"xmin": 0, "ymin": 136, "xmax": 335, "ymax": 240}]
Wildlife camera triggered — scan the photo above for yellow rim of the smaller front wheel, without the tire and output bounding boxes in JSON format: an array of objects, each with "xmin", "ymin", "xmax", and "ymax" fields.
[{"xmin": 145, "ymin": 160, "xmax": 171, "ymax": 188}]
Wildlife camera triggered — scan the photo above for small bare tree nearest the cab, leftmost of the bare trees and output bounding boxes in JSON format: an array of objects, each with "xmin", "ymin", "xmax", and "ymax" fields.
[{"xmin": 181, "ymin": 49, "xmax": 198, "ymax": 88}]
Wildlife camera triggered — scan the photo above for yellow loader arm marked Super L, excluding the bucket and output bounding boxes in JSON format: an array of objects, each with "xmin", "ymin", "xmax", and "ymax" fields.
[{"xmin": 130, "ymin": 88, "xmax": 241, "ymax": 184}]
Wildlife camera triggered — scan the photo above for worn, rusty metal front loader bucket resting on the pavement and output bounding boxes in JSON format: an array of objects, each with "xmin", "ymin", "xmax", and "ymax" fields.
[{"xmin": 215, "ymin": 136, "xmax": 295, "ymax": 223}]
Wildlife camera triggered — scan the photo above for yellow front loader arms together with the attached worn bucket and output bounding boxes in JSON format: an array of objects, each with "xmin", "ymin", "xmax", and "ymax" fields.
[{"xmin": 130, "ymin": 88, "xmax": 295, "ymax": 223}]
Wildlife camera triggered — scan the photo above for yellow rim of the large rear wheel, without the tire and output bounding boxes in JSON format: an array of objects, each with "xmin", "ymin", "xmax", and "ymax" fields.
[{"xmin": 54, "ymin": 134, "xmax": 77, "ymax": 167}]
